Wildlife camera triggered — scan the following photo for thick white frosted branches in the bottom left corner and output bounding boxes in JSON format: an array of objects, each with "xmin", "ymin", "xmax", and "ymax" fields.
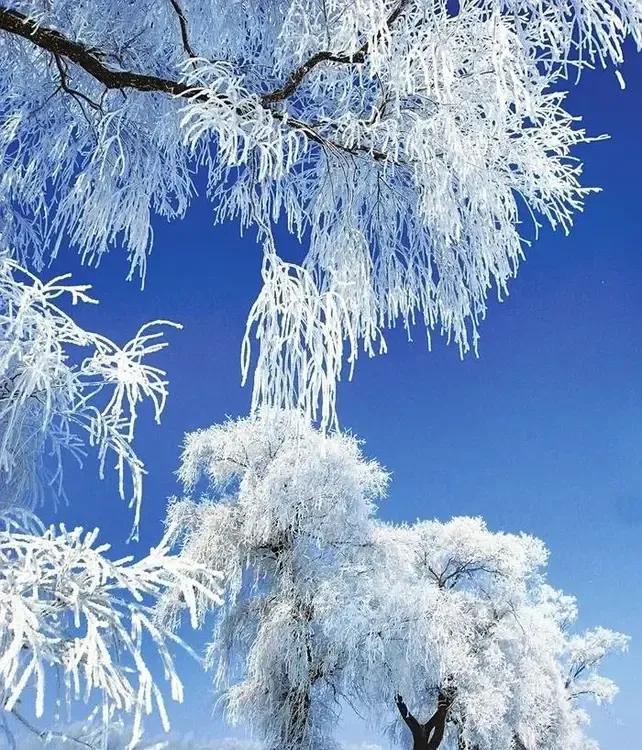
[{"xmin": 0, "ymin": 517, "xmax": 220, "ymax": 748}]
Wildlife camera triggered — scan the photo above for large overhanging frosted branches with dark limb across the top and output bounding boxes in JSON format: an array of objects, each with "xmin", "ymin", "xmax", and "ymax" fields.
[{"xmin": 0, "ymin": 0, "xmax": 642, "ymax": 424}]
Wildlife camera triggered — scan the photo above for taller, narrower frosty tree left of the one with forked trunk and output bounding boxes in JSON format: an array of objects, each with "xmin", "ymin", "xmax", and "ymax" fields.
[{"xmin": 163, "ymin": 413, "xmax": 387, "ymax": 750}]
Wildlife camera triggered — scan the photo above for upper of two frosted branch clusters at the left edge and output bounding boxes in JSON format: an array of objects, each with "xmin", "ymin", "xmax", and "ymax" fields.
[{"xmin": 0, "ymin": 254, "xmax": 180, "ymax": 531}]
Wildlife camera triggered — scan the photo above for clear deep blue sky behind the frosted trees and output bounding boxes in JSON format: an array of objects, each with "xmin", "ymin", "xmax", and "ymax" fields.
[{"xmin": 47, "ymin": 47, "xmax": 642, "ymax": 750}]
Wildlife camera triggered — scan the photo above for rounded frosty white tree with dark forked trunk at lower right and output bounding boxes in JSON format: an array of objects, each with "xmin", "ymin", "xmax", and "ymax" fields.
[{"xmin": 332, "ymin": 518, "xmax": 628, "ymax": 750}]
